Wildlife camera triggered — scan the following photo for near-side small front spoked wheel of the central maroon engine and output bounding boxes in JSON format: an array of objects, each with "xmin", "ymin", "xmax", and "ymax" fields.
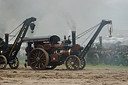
[{"xmin": 65, "ymin": 55, "xmax": 80, "ymax": 70}]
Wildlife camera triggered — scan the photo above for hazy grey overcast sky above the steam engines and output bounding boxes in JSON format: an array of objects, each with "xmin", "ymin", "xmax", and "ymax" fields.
[{"xmin": 0, "ymin": 0, "xmax": 128, "ymax": 44}]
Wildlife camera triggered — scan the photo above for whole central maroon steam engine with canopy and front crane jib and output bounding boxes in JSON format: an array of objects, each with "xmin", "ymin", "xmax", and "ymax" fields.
[{"xmin": 24, "ymin": 20, "xmax": 112, "ymax": 70}]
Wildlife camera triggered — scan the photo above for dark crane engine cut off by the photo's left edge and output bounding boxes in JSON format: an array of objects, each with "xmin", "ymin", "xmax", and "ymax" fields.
[{"xmin": 0, "ymin": 17, "xmax": 36, "ymax": 69}]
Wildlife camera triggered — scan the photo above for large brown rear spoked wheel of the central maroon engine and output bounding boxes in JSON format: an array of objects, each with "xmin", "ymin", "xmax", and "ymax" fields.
[{"xmin": 28, "ymin": 48, "xmax": 49, "ymax": 70}]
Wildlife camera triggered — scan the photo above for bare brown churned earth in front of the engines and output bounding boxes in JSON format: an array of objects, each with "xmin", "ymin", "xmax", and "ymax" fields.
[{"xmin": 0, "ymin": 66, "xmax": 128, "ymax": 85}]
